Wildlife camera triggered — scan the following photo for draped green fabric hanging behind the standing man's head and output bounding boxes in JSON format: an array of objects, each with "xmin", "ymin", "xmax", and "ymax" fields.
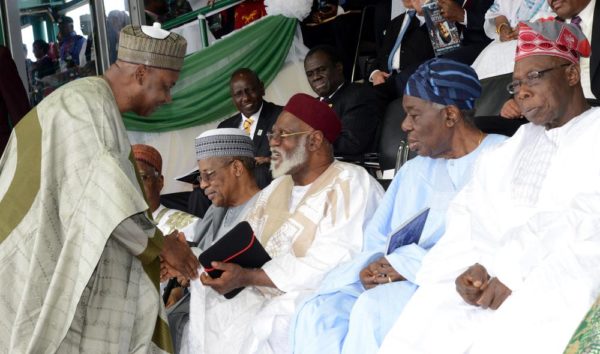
[{"xmin": 123, "ymin": 16, "xmax": 297, "ymax": 132}]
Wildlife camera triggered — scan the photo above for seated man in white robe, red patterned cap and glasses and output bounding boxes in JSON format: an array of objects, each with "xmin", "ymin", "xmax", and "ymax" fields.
[{"xmin": 380, "ymin": 20, "xmax": 600, "ymax": 354}]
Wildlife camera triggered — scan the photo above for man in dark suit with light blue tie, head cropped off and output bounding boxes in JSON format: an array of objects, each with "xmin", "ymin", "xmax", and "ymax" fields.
[{"xmin": 369, "ymin": 0, "xmax": 434, "ymax": 101}]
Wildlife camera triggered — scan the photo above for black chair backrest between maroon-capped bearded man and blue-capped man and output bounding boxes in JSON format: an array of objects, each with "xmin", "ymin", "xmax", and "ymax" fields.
[{"xmin": 378, "ymin": 98, "xmax": 406, "ymax": 170}]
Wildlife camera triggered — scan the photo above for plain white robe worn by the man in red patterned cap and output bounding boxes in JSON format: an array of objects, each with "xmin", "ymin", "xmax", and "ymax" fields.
[{"xmin": 380, "ymin": 108, "xmax": 600, "ymax": 354}]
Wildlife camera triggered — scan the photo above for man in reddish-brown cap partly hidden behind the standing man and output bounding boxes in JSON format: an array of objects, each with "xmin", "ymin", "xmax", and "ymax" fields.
[{"xmin": 131, "ymin": 144, "xmax": 201, "ymax": 241}]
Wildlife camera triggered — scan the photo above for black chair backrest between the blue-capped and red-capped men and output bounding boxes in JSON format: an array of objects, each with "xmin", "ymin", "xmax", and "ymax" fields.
[{"xmin": 475, "ymin": 73, "xmax": 512, "ymax": 116}]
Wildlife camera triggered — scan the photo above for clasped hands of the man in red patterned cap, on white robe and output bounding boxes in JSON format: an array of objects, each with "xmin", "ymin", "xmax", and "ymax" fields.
[{"xmin": 454, "ymin": 263, "xmax": 512, "ymax": 310}]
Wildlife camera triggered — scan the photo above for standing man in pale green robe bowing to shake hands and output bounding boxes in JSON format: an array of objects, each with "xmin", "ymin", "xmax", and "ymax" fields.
[{"xmin": 0, "ymin": 26, "xmax": 198, "ymax": 353}]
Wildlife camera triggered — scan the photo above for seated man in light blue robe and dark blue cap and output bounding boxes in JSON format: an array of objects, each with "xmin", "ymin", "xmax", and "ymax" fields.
[{"xmin": 292, "ymin": 59, "xmax": 505, "ymax": 353}]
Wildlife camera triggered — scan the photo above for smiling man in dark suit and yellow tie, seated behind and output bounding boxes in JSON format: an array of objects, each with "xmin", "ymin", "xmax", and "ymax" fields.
[{"xmin": 219, "ymin": 68, "xmax": 282, "ymax": 189}]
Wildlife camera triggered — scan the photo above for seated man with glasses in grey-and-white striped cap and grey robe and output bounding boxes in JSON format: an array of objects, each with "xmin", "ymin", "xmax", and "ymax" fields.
[{"xmin": 162, "ymin": 128, "xmax": 260, "ymax": 352}]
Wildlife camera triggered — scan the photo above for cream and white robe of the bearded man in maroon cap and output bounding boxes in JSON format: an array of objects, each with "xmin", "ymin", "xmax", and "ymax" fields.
[{"xmin": 188, "ymin": 162, "xmax": 383, "ymax": 354}]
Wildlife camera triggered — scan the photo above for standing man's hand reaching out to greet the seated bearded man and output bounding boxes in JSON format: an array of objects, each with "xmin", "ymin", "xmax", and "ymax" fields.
[{"xmin": 160, "ymin": 230, "xmax": 200, "ymax": 280}]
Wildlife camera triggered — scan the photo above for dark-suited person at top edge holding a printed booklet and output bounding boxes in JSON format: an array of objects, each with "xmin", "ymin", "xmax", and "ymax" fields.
[{"xmin": 438, "ymin": 0, "xmax": 494, "ymax": 65}]
